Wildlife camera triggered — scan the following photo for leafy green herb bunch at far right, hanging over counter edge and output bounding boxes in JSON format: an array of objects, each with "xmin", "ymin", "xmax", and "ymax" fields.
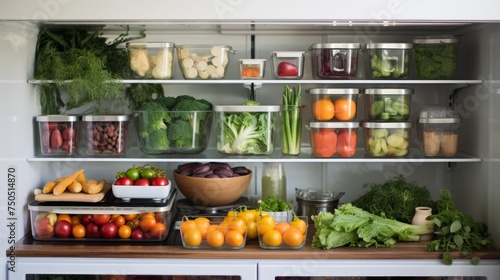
[{"xmin": 427, "ymin": 190, "xmax": 493, "ymax": 264}]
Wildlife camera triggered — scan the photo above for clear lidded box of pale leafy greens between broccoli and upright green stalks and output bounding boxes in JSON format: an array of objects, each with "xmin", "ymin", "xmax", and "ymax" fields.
[{"xmin": 214, "ymin": 105, "xmax": 280, "ymax": 155}]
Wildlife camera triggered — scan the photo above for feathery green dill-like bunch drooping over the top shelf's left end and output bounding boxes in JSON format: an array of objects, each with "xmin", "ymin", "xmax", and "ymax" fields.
[{"xmin": 34, "ymin": 26, "xmax": 145, "ymax": 115}]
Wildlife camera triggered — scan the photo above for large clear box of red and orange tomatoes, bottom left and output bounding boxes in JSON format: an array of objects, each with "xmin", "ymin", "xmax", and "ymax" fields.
[{"xmin": 28, "ymin": 189, "xmax": 177, "ymax": 243}]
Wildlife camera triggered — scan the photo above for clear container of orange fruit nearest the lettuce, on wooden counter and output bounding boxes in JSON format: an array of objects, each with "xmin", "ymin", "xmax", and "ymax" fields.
[{"xmin": 257, "ymin": 215, "xmax": 308, "ymax": 250}]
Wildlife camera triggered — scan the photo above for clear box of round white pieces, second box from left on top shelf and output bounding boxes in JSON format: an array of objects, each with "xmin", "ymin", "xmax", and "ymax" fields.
[{"xmin": 176, "ymin": 44, "xmax": 234, "ymax": 80}]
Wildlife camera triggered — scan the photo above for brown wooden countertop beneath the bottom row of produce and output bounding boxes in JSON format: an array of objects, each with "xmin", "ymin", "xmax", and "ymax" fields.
[{"xmin": 11, "ymin": 233, "xmax": 500, "ymax": 260}]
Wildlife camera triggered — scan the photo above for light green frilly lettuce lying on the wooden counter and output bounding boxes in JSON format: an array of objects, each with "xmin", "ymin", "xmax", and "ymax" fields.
[{"xmin": 312, "ymin": 203, "xmax": 433, "ymax": 249}]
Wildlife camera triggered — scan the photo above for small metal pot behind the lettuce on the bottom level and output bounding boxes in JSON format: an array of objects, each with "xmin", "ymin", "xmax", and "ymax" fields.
[{"xmin": 295, "ymin": 188, "xmax": 345, "ymax": 223}]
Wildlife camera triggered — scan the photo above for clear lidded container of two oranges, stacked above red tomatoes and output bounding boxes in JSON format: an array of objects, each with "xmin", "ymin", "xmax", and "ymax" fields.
[{"xmin": 307, "ymin": 88, "xmax": 361, "ymax": 122}]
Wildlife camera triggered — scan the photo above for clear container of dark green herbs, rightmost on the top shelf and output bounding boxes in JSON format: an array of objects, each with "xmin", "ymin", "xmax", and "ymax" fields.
[{"xmin": 413, "ymin": 38, "xmax": 460, "ymax": 80}]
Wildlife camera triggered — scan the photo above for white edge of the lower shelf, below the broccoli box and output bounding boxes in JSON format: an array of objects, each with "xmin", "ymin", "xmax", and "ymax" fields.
[{"xmin": 27, "ymin": 147, "xmax": 481, "ymax": 163}]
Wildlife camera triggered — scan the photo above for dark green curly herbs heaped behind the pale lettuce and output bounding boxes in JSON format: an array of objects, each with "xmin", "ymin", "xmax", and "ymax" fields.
[{"xmin": 351, "ymin": 175, "xmax": 435, "ymax": 223}]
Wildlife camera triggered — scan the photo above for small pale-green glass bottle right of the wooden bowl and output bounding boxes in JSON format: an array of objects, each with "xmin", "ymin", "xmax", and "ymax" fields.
[{"xmin": 262, "ymin": 162, "xmax": 286, "ymax": 201}]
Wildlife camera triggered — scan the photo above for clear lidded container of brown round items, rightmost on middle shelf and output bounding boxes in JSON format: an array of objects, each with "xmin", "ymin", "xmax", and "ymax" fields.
[{"xmin": 418, "ymin": 106, "xmax": 461, "ymax": 157}]
